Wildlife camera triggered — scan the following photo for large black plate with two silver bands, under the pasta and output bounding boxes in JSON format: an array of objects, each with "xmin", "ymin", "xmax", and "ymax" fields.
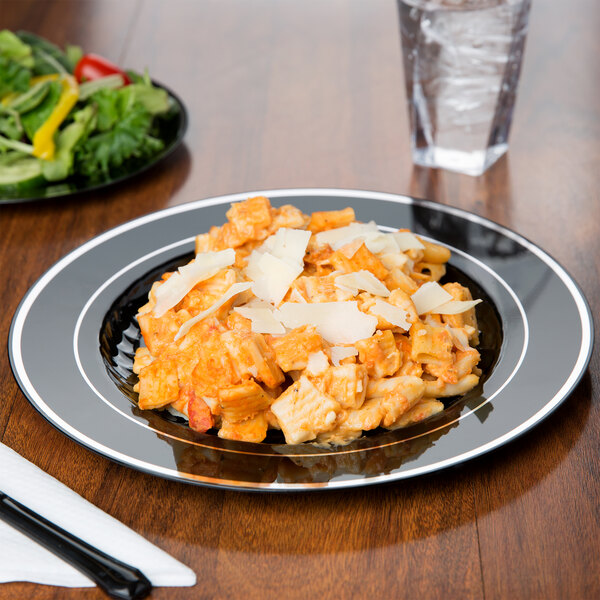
[{"xmin": 9, "ymin": 189, "xmax": 593, "ymax": 492}]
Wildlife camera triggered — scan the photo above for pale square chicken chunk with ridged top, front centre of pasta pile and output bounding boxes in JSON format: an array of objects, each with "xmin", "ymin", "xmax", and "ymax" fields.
[{"xmin": 271, "ymin": 376, "xmax": 341, "ymax": 444}]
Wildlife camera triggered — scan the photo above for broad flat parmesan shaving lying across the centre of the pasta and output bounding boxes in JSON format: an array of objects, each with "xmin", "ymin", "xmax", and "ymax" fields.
[{"xmin": 279, "ymin": 301, "xmax": 377, "ymax": 344}]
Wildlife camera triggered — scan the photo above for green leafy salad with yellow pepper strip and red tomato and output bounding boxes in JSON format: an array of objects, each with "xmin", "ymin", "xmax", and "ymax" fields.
[{"xmin": 0, "ymin": 30, "xmax": 172, "ymax": 195}]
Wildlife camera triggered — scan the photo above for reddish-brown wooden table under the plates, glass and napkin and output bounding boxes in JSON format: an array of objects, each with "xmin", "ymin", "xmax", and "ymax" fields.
[{"xmin": 0, "ymin": 0, "xmax": 600, "ymax": 600}]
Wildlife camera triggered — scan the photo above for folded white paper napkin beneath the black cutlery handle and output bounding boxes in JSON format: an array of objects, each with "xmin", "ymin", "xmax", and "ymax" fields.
[{"xmin": 0, "ymin": 443, "xmax": 196, "ymax": 587}]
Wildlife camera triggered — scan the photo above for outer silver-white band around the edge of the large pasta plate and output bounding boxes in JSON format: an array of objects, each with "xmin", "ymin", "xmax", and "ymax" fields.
[{"xmin": 8, "ymin": 188, "xmax": 594, "ymax": 492}]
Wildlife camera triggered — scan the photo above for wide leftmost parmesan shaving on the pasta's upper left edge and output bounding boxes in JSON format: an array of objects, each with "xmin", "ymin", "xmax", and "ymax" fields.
[{"xmin": 153, "ymin": 248, "xmax": 235, "ymax": 318}]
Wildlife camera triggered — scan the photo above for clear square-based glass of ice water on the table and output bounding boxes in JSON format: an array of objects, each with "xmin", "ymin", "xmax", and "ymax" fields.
[{"xmin": 398, "ymin": 0, "xmax": 531, "ymax": 175}]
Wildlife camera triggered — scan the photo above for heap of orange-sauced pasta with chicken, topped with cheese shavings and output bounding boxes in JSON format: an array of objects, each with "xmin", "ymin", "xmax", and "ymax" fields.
[{"xmin": 134, "ymin": 197, "xmax": 480, "ymax": 444}]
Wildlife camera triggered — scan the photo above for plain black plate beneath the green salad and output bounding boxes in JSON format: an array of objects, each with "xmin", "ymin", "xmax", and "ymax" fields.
[{"xmin": 0, "ymin": 81, "xmax": 188, "ymax": 205}]
